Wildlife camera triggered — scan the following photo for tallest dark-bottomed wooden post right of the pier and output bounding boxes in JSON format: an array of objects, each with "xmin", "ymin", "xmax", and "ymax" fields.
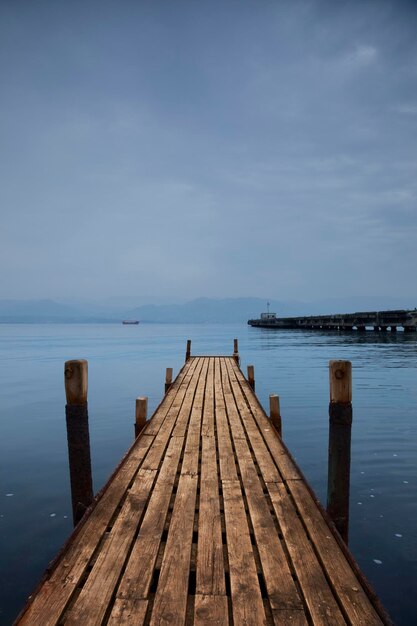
[{"xmin": 327, "ymin": 361, "xmax": 352, "ymax": 544}]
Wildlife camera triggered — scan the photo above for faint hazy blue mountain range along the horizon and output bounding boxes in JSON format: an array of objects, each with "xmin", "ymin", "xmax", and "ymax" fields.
[{"xmin": 0, "ymin": 296, "xmax": 417, "ymax": 324}]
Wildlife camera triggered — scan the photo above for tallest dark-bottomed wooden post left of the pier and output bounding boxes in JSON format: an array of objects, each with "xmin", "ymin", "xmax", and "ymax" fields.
[{"xmin": 64, "ymin": 359, "xmax": 94, "ymax": 526}]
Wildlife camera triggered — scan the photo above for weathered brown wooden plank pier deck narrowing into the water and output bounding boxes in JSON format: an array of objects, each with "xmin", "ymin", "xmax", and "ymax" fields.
[{"xmin": 16, "ymin": 354, "xmax": 390, "ymax": 626}]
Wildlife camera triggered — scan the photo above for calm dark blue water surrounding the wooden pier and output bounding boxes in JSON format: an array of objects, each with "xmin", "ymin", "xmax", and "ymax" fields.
[{"xmin": 0, "ymin": 324, "xmax": 417, "ymax": 626}]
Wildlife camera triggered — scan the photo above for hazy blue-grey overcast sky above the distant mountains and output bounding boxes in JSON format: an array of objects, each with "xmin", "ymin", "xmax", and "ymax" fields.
[{"xmin": 0, "ymin": 0, "xmax": 417, "ymax": 300}]
